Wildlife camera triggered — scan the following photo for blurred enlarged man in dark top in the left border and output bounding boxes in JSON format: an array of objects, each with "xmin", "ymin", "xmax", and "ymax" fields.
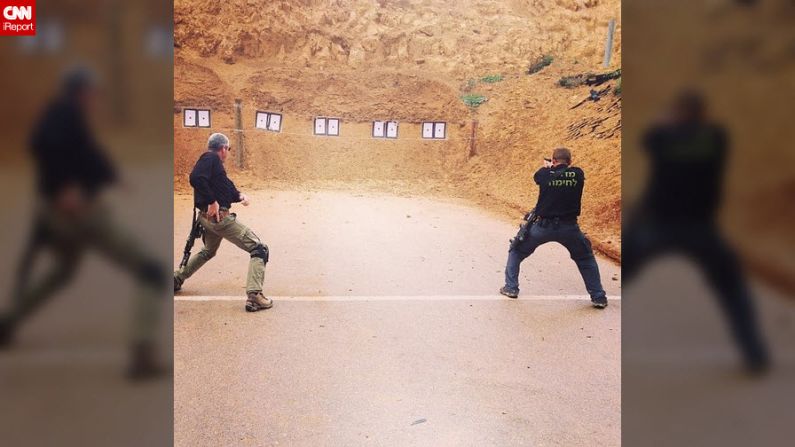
[{"xmin": 0, "ymin": 67, "xmax": 167, "ymax": 379}]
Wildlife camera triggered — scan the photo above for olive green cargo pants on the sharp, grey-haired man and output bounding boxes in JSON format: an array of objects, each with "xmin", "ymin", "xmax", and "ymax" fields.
[{"xmin": 174, "ymin": 213, "xmax": 265, "ymax": 293}]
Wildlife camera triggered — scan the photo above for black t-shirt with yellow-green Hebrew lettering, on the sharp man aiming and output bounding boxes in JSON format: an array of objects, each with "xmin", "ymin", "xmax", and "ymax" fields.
[{"xmin": 533, "ymin": 165, "xmax": 585, "ymax": 219}]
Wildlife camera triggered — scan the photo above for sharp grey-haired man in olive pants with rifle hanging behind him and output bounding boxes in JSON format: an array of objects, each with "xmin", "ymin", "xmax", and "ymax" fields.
[{"xmin": 174, "ymin": 133, "xmax": 273, "ymax": 312}]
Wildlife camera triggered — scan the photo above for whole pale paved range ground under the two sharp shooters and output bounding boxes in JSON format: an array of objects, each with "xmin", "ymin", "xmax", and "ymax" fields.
[{"xmin": 174, "ymin": 191, "xmax": 621, "ymax": 446}]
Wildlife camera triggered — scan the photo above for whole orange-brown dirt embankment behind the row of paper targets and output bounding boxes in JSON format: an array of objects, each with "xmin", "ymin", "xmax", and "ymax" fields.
[{"xmin": 174, "ymin": 0, "xmax": 621, "ymax": 259}]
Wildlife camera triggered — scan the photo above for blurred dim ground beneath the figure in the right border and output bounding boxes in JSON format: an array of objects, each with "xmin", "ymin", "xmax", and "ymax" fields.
[{"xmin": 622, "ymin": 257, "xmax": 795, "ymax": 447}]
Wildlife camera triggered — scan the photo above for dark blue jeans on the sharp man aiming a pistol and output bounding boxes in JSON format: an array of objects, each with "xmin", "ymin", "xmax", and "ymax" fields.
[{"xmin": 505, "ymin": 221, "xmax": 605, "ymax": 299}]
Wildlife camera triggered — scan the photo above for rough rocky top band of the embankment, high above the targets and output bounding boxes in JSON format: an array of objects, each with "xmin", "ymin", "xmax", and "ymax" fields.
[{"xmin": 174, "ymin": 0, "xmax": 620, "ymax": 71}]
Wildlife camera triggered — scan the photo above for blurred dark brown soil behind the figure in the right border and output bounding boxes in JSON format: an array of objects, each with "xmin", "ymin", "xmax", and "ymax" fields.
[{"xmin": 622, "ymin": 2, "xmax": 795, "ymax": 297}]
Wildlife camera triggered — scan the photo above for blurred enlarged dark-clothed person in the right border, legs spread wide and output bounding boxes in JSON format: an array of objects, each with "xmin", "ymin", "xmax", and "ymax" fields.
[{"xmin": 622, "ymin": 91, "xmax": 770, "ymax": 373}]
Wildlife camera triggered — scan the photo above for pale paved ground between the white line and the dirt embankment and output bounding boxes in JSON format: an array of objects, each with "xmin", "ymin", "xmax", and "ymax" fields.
[{"xmin": 174, "ymin": 191, "xmax": 621, "ymax": 297}]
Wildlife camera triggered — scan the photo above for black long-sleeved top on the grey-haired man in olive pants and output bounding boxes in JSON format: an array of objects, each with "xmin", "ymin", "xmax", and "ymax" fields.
[{"xmin": 190, "ymin": 151, "xmax": 240, "ymax": 209}]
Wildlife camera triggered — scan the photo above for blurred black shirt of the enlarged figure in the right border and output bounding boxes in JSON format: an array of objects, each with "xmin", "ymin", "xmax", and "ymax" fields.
[{"xmin": 643, "ymin": 123, "xmax": 728, "ymax": 219}]
